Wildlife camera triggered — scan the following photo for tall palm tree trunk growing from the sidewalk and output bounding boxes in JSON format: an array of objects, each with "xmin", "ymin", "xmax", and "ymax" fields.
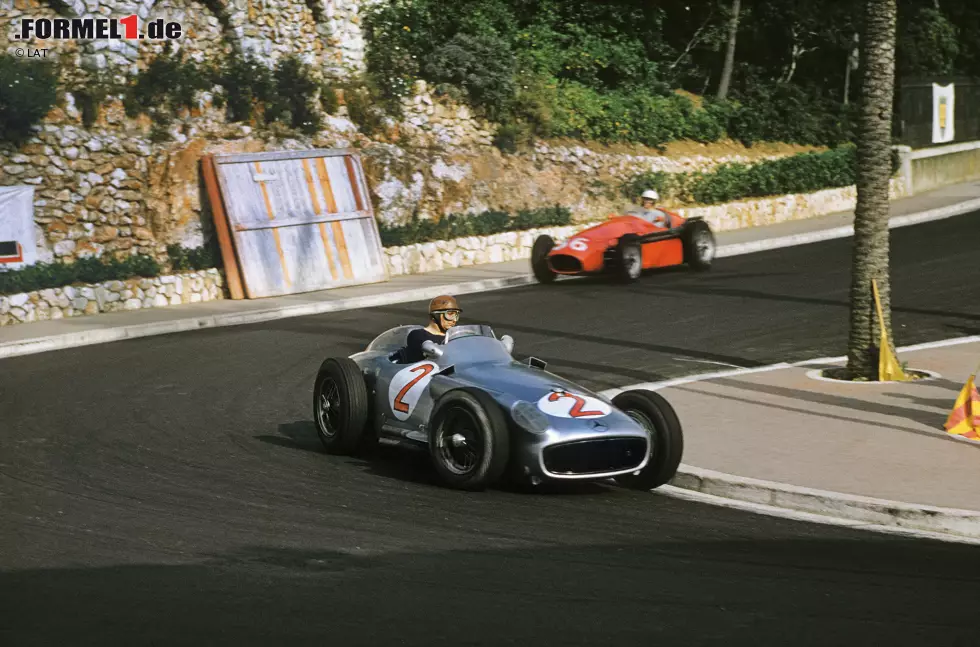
[{"xmin": 847, "ymin": 0, "xmax": 897, "ymax": 380}]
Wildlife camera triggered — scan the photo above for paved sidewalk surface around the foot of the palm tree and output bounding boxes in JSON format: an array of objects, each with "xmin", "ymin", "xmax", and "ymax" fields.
[{"xmin": 661, "ymin": 340, "xmax": 980, "ymax": 515}]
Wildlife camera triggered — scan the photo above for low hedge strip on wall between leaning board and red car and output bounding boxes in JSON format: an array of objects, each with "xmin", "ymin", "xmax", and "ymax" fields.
[{"xmin": 378, "ymin": 205, "xmax": 572, "ymax": 247}]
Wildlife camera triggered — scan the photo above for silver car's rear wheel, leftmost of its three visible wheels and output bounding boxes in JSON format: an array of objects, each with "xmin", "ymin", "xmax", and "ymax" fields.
[{"xmin": 313, "ymin": 357, "xmax": 369, "ymax": 455}]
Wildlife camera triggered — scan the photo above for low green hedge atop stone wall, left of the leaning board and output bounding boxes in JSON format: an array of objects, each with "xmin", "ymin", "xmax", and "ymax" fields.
[{"xmin": 0, "ymin": 245, "xmax": 216, "ymax": 295}]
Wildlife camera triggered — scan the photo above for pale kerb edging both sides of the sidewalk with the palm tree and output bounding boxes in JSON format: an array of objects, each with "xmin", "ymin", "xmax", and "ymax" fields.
[{"xmin": 602, "ymin": 335, "xmax": 980, "ymax": 544}]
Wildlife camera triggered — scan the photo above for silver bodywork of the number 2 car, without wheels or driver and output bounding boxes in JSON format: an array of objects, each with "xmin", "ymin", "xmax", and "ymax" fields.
[{"xmin": 350, "ymin": 325, "xmax": 650, "ymax": 479}]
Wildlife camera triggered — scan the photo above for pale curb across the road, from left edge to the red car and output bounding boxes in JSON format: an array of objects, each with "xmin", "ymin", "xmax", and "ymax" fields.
[{"xmin": 0, "ymin": 275, "xmax": 534, "ymax": 359}]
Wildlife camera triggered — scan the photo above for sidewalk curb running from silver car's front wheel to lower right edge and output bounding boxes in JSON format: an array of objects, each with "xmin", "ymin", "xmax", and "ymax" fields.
[{"xmin": 670, "ymin": 465, "xmax": 980, "ymax": 539}]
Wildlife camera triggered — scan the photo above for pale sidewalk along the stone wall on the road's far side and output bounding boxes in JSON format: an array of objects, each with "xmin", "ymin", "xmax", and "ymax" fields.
[{"xmin": 0, "ymin": 182, "xmax": 980, "ymax": 359}]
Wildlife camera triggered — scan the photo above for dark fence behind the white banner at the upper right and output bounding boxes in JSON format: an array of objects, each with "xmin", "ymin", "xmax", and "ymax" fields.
[{"xmin": 895, "ymin": 77, "xmax": 980, "ymax": 149}]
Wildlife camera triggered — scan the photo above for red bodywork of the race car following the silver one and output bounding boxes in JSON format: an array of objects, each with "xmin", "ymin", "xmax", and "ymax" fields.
[{"xmin": 548, "ymin": 209, "xmax": 686, "ymax": 274}]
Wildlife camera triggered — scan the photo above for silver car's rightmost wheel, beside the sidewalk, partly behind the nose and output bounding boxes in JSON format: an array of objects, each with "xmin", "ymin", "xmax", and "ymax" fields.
[{"xmin": 613, "ymin": 389, "xmax": 684, "ymax": 490}]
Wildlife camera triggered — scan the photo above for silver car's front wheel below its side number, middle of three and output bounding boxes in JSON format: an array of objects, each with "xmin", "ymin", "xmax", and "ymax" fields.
[{"xmin": 429, "ymin": 389, "xmax": 510, "ymax": 490}]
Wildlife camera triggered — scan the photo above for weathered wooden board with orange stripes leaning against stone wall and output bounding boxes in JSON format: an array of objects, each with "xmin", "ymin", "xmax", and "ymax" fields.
[{"xmin": 213, "ymin": 149, "xmax": 388, "ymax": 299}]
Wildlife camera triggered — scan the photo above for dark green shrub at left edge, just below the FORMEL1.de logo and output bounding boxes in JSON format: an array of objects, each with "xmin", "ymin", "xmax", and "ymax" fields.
[{"xmin": 0, "ymin": 53, "xmax": 58, "ymax": 146}]
